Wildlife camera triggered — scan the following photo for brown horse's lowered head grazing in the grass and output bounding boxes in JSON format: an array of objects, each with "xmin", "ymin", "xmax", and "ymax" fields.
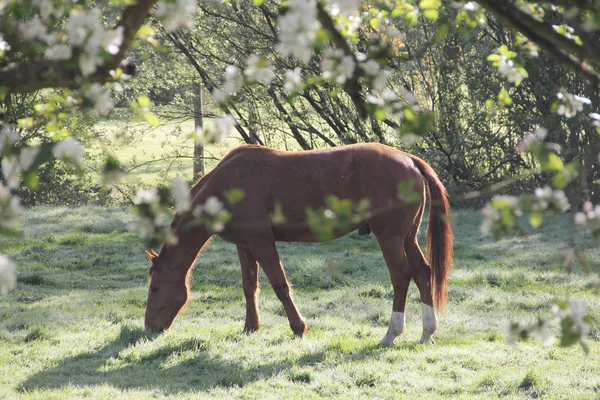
[{"xmin": 145, "ymin": 251, "xmax": 189, "ymax": 332}]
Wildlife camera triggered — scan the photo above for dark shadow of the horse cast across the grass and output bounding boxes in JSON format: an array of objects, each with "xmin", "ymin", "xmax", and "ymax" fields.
[{"xmin": 18, "ymin": 327, "xmax": 404, "ymax": 395}]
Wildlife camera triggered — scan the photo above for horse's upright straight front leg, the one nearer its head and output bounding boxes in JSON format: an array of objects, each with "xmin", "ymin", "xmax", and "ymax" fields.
[{"xmin": 237, "ymin": 246, "xmax": 260, "ymax": 332}]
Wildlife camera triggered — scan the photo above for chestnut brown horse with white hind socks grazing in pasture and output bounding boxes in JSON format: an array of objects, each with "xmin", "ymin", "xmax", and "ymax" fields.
[{"xmin": 145, "ymin": 143, "xmax": 453, "ymax": 345}]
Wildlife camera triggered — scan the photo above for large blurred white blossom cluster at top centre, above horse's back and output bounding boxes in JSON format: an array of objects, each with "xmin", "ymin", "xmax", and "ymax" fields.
[{"xmin": 278, "ymin": 0, "xmax": 319, "ymax": 62}]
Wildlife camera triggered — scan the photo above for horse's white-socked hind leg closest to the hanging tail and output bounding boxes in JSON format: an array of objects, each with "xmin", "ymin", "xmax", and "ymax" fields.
[{"xmin": 404, "ymin": 237, "xmax": 437, "ymax": 343}]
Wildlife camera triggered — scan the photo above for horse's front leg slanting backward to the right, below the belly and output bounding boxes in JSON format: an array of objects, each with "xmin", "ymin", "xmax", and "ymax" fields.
[{"xmin": 249, "ymin": 238, "xmax": 306, "ymax": 337}]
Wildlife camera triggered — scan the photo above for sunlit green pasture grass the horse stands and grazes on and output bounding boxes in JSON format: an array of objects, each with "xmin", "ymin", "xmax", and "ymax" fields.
[{"xmin": 0, "ymin": 207, "xmax": 600, "ymax": 399}]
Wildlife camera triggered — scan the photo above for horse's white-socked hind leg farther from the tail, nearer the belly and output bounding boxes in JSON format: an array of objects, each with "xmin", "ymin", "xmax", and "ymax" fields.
[{"xmin": 377, "ymin": 235, "xmax": 412, "ymax": 346}]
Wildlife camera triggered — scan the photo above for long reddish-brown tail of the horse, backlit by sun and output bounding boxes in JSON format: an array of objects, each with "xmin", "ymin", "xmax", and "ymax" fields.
[{"xmin": 409, "ymin": 154, "xmax": 454, "ymax": 311}]
